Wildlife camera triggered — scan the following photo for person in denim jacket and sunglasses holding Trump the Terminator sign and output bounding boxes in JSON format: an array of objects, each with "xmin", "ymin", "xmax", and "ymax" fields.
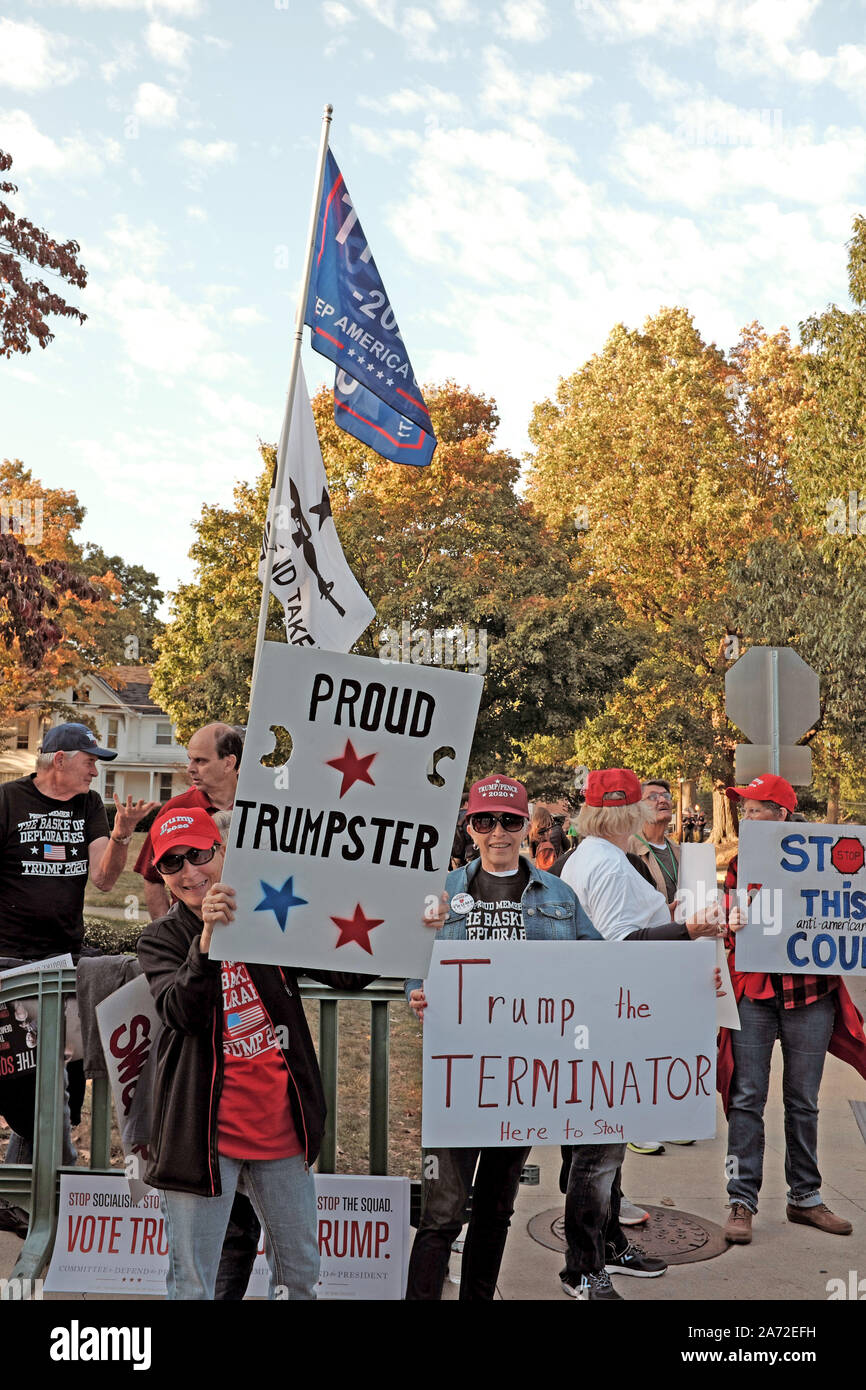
[{"xmin": 406, "ymin": 776, "xmax": 605, "ymax": 1301}]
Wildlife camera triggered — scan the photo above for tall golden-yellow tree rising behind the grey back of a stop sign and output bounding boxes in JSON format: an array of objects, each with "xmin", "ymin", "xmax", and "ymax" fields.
[{"xmin": 528, "ymin": 309, "xmax": 802, "ymax": 835}]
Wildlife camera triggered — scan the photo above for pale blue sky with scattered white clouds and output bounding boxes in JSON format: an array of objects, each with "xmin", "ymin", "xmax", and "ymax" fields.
[{"xmin": 0, "ymin": 0, "xmax": 866, "ymax": 606}]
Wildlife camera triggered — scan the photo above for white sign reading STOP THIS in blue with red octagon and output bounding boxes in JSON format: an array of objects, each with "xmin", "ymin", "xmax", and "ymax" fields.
[{"xmin": 737, "ymin": 820, "xmax": 866, "ymax": 974}]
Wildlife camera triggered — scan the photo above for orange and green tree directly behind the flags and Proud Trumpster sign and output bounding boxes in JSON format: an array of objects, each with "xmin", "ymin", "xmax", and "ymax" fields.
[{"xmin": 154, "ymin": 382, "xmax": 637, "ymax": 778}]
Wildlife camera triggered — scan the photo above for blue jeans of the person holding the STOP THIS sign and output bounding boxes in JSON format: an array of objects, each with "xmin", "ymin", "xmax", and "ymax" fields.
[{"xmin": 727, "ymin": 994, "xmax": 835, "ymax": 1212}]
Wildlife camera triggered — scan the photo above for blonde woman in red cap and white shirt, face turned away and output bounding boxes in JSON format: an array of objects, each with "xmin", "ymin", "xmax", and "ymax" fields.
[{"xmin": 560, "ymin": 767, "xmax": 724, "ymax": 1302}]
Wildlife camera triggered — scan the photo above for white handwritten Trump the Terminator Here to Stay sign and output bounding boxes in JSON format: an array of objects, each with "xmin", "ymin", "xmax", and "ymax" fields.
[{"xmin": 423, "ymin": 941, "xmax": 716, "ymax": 1148}]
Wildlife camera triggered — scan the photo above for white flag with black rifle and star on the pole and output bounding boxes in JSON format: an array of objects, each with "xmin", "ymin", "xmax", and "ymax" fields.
[{"xmin": 259, "ymin": 364, "xmax": 375, "ymax": 652}]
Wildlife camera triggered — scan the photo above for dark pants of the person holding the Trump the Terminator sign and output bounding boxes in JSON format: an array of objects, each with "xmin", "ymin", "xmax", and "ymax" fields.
[{"xmin": 406, "ymin": 1148, "xmax": 531, "ymax": 1302}]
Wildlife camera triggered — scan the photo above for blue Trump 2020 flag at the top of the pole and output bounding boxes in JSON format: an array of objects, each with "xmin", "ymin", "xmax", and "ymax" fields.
[{"xmin": 304, "ymin": 150, "xmax": 435, "ymax": 463}]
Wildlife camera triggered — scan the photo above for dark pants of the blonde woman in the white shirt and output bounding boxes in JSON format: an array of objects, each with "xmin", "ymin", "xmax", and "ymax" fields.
[{"xmin": 563, "ymin": 1144, "xmax": 628, "ymax": 1277}]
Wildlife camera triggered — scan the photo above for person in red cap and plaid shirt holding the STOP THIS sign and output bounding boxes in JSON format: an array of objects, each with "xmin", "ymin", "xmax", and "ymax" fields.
[{"xmin": 717, "ymin": 773, "xmax": 866, "ymax": 1245}]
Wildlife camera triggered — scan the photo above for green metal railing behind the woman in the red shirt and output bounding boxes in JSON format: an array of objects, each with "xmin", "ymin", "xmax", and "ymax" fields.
[{"xmin": 0, "ymin": 970, "xmax": 420, "ymax": 1298}]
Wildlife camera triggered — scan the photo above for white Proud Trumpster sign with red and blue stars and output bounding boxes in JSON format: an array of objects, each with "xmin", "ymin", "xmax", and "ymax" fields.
[{"xmin": 210, "ymin": 642, "xmax": 482, "ymax": 976}]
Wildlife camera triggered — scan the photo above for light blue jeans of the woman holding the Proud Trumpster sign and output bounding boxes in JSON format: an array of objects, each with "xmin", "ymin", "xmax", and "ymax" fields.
[{"xmin": 160, "ymin": 1154, "xmax": 318, "ymax": 1300}]
